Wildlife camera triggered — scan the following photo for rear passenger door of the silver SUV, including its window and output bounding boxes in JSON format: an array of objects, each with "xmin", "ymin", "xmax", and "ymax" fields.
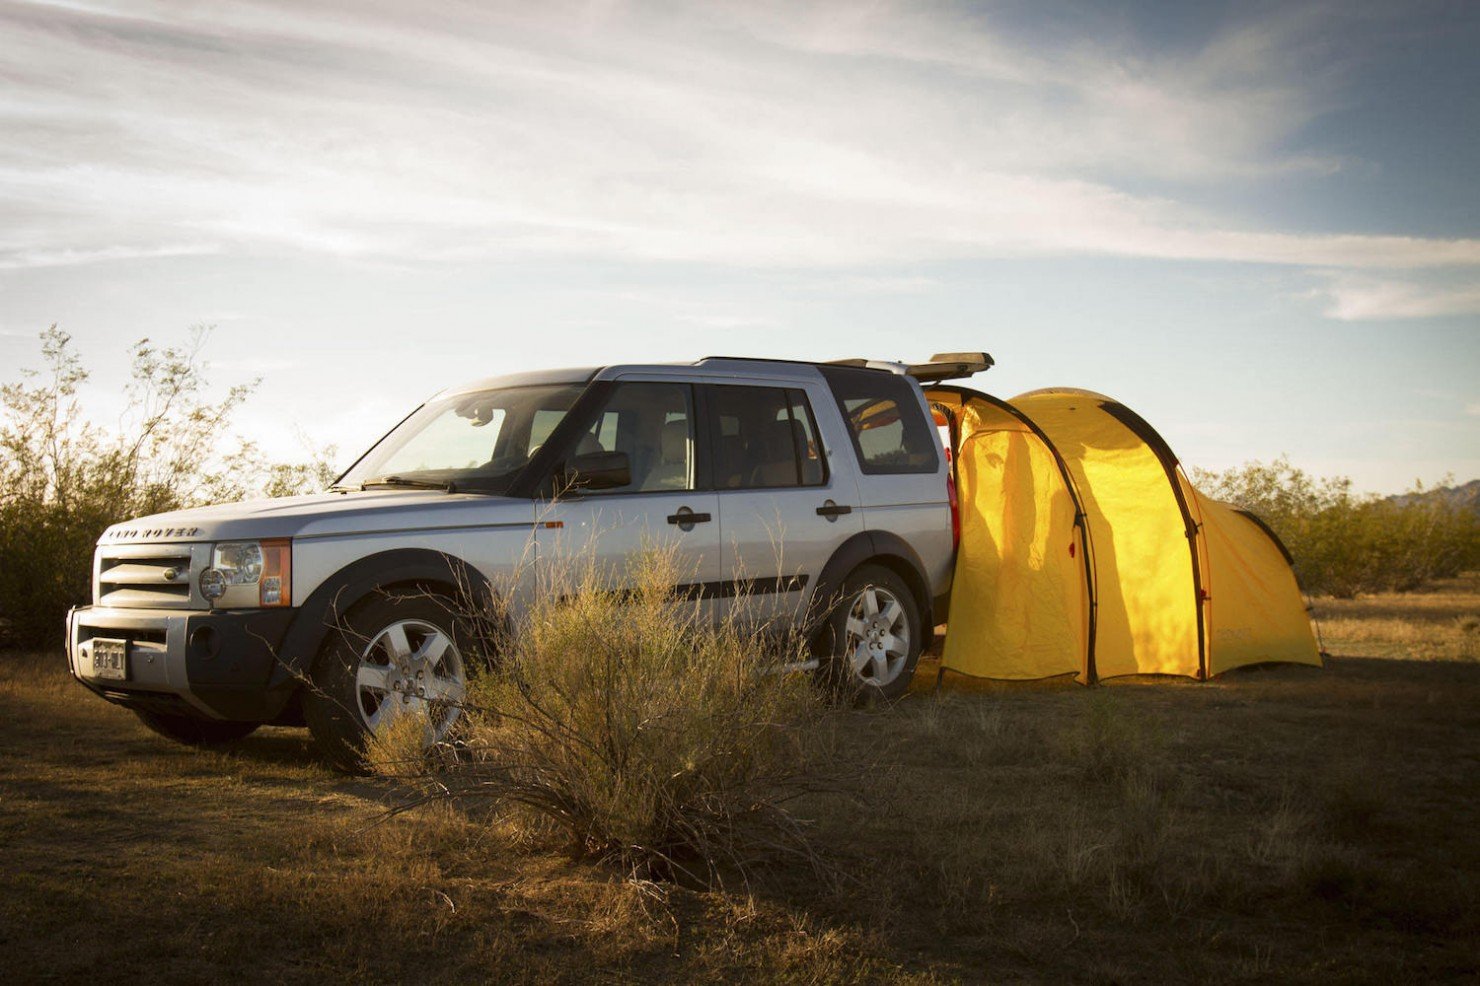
[{"xmin": 702, "ymin": 379, "xmax": 863, "ymax": 623}]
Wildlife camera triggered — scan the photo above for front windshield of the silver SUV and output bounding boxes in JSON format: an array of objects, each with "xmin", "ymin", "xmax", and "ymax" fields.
[{"xmin": 336, "ymin": 383, "xmax": 586, "ymax": 493}]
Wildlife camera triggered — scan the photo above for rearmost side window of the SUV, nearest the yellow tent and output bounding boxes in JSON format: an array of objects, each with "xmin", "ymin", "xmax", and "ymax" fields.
[{"xmin": 818, "ymin": 366, "xmax": 940, "ymax": 475}]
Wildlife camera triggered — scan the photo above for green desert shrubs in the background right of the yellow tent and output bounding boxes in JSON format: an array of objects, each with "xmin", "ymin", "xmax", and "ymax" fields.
[{"xmin": 1193, "ymin": 459, "xmax": 1480, "ymax": 598}]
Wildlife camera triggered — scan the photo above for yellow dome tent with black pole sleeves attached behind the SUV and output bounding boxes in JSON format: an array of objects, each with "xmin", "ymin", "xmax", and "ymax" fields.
[{"xmin": 926, "ymin": 386, "xmax": 1320, "ymax": 683}]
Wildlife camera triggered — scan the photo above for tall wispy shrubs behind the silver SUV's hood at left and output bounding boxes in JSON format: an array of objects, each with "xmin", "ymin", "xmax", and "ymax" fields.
[{"xmin": 0, "ymin": 326, "xmax": 332, "ymax": 645}]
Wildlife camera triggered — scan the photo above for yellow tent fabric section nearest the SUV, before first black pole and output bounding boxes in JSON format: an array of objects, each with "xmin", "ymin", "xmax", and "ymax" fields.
[{"xmin": 946, "ymin": 390, "xmax": 1089, "ymax": 678}]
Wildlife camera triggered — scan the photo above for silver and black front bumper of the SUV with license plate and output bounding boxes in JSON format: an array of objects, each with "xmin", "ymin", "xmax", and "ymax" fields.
[{"xmin": 67, "ymin": 606, "xmax": 297, "ymax": 722}]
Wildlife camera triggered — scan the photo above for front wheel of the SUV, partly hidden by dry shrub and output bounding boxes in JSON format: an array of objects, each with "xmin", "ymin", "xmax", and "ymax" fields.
[{"xmin": 303, "ymin": 592, "xmax": 468, "ymax": 774}]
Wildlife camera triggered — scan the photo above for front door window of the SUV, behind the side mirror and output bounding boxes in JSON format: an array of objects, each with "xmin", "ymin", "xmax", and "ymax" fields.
[{"xmin": 574, "ymin": 383, "xmax": 694, "ymax": 494}]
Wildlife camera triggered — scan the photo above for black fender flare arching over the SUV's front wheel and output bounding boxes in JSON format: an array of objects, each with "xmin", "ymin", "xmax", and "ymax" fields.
[{"xmin": 268, "ymin": 548, "xmax": 496, "ymax": 691}]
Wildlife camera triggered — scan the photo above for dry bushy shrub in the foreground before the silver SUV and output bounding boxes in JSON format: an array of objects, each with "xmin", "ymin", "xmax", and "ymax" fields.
[{"xmin": 381, "ymin": 551, "xmax": 824, "ymax": 884}]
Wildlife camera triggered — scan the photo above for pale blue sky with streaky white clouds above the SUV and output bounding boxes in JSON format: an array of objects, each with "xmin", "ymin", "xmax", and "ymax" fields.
[{"xmin": 0, "ymin": 0, "xmax": 1480, "ymax": 493}]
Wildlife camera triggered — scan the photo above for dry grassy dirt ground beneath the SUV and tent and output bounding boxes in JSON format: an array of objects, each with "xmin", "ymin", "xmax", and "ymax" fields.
[{"xmin": 0, "ymin": 576, "xmax": 1480, "ymax": 983}]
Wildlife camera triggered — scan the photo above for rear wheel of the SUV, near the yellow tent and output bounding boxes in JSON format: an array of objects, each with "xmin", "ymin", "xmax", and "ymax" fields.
[{"xmin": 824, "ymin": 564, "xmax": 925, "ymax": 705}]
